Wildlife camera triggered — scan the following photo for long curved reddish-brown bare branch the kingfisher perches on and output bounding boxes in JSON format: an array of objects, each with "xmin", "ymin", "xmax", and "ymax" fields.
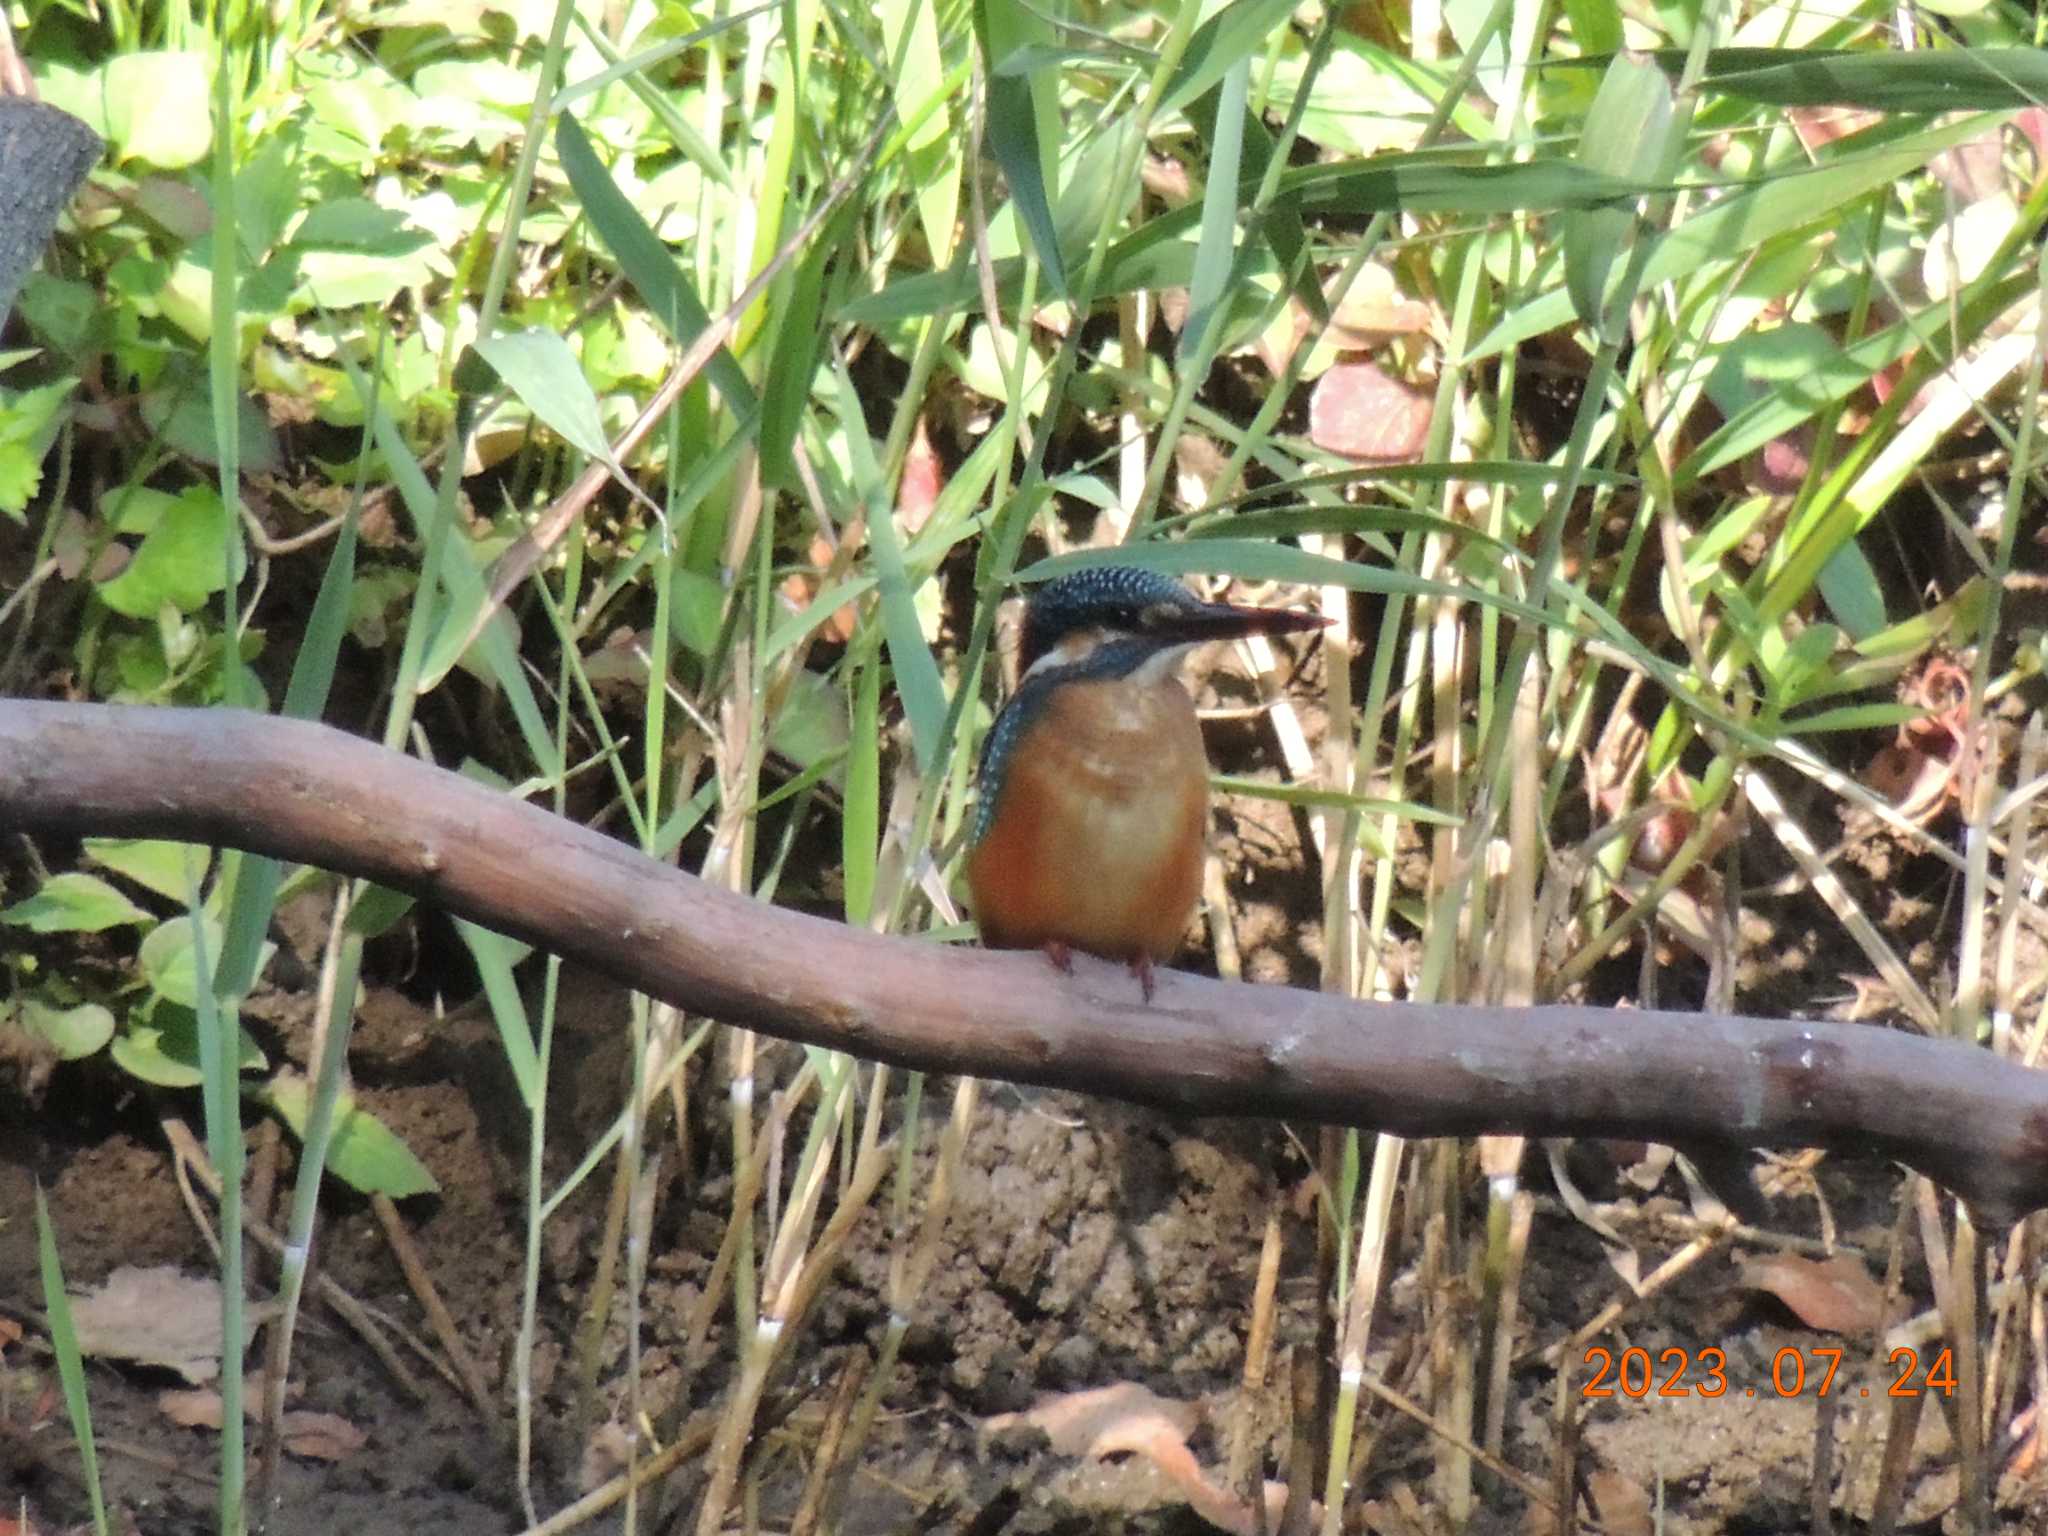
[{"xmin": 12, "ymin": 700, "xmax": 2048, "ymax": 1221}]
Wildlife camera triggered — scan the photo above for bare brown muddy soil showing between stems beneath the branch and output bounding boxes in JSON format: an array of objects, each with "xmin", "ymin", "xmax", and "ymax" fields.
[{"xmin": 0, "ymin": 786, "xmax": 2048, "ymax": 1536}]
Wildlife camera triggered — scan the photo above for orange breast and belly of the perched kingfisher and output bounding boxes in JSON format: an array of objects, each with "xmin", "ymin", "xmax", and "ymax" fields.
[{"xmin": 967, "ymin": 678, "xmax": 1208, "ymax": 961}]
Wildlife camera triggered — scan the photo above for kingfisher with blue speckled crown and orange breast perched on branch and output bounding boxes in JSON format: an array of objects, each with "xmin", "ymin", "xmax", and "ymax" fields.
[{"xmin": 967, "ymin": 565, "xmax": 1329, "ymax": 1001}]
